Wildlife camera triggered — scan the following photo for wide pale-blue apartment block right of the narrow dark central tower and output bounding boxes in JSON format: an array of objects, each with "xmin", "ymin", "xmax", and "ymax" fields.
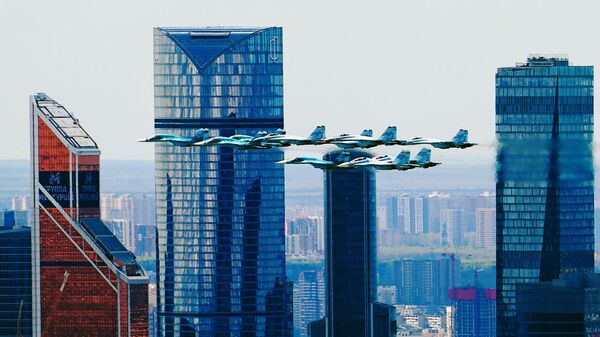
[{"xmin": 394, "ymin": 256, "xmax": 461, "ymax": 306}]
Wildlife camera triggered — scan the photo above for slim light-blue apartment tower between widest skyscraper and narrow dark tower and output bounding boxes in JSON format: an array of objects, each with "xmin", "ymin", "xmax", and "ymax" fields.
[{"xmin": 294, "ymin": 271, "xmax": 325, "ymax": 337}]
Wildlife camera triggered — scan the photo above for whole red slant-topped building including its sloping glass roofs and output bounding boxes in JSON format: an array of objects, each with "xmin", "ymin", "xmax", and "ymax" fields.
[{"xmin": 30, "ymin": 94, "xmax": 148, "ymax": 337}]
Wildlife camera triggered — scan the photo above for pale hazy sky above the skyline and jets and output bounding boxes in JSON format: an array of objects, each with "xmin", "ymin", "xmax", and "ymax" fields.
[{"xmin": 0, "ymin": 0, "xmax": 600, "ymax": 160}]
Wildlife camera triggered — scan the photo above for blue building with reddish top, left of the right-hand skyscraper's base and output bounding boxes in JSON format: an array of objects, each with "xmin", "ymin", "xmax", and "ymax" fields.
[{"xmin": 449, "ymin": 287, "xmax": 496, "ymax": 337}]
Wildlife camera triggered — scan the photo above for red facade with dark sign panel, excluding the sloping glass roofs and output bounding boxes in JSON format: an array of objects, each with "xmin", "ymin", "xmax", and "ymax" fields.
[{"xmin": 32, "ymin": 95, "xmax": 148, "ymax": 337}]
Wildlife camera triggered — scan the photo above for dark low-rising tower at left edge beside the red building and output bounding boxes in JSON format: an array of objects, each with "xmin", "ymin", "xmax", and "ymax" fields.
[{"xmin": 0, "ymin": 227, "xmax": 31, "ymax": 337}]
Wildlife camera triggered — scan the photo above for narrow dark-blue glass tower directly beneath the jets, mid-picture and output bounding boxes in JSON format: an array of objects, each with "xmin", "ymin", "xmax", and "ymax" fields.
[{"xmin": 323, "ymin": 151, "xmax": 376, "ymax": 337}]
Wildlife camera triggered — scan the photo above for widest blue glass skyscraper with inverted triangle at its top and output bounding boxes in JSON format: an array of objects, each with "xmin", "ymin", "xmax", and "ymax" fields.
[{"xmin": 154, "ymin": 27, "xmax": 292, "ymax": 337}]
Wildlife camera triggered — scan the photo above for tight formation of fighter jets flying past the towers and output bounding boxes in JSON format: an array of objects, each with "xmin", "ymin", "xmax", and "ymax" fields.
[{"xmin": 138, "ymin": 125, "xmax": 477, "ymax": 171}]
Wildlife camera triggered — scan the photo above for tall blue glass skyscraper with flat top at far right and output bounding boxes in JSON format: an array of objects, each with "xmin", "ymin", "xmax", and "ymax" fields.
[{"xmin": 496, "ymin": 55, "xmax": 594, "ymax": 336}]
